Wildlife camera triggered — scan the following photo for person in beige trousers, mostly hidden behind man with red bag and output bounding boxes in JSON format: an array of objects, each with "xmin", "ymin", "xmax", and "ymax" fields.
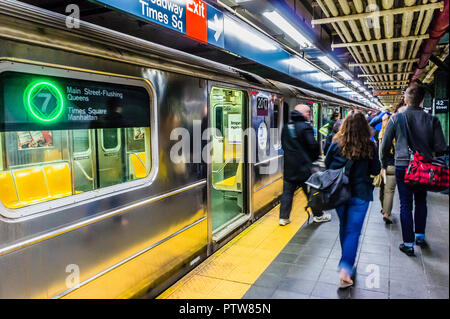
[{"xmin": 378, "ymin": 107, "xmax": 398, "ymax": 224}]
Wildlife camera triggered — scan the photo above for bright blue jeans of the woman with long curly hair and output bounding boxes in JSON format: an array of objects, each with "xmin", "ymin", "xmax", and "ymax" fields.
[{"xmin": 336, "ymin": 197, "xmax": 369, "ymax": 275}]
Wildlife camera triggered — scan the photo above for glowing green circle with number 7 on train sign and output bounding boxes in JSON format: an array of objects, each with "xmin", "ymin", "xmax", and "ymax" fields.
[{"xmin": 25, "ymin": 82, "xmax": 64, "ymax": 122}]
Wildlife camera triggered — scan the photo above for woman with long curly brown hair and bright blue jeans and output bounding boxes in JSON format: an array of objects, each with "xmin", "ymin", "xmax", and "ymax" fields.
[{"xmin": 325, "ymin": 111, "xmax": 381, "ymax": 288}]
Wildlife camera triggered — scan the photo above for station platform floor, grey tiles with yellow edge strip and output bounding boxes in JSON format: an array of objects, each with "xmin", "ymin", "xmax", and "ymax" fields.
[{"xmin": 158, "ymin": 189, "xmax": 449, "ymax": 299}]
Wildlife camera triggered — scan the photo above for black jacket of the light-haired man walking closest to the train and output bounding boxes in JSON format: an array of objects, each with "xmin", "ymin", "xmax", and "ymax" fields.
[{"xmin": 281, "ymin": 110, "xmax": 320, "ymax": 183}]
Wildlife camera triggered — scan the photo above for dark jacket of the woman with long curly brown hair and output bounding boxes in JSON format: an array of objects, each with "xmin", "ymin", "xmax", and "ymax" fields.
[{"xmin": 325, "ymin": 142, "xmax": 381, "ymax": 202}]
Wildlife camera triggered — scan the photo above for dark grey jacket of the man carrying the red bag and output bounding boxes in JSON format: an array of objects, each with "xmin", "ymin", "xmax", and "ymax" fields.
[{"xmin": 380, "ymin": 106, "xmax": 447, "ymax": 167}]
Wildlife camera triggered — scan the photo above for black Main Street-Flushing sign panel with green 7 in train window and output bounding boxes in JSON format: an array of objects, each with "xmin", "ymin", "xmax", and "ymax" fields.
[{"xmin": 0, "ymin": 71, "xmax": 150, "ymax": 131}]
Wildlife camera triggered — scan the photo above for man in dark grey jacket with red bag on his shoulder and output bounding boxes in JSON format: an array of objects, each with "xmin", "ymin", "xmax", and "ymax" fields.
[{"xmin": 381, "ymin": 83, "xmax": 447, "ymax": 256}]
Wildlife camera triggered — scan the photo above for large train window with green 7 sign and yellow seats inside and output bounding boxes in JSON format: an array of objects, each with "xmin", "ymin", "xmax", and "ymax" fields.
[{"xmin": 0, "ymin": 67, "xmax": 152, "ymax": 215}]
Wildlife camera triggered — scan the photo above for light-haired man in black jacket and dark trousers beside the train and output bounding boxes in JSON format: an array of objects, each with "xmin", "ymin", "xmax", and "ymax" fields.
[{"xmin": 279, "ymin": 104, "xmax": 331, "ymax": 226}]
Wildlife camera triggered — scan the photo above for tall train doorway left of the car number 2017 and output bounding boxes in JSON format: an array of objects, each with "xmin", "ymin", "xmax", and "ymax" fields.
[{"xmin": 209, "ymin": 87, "xmax": 248, "ymax": 241}]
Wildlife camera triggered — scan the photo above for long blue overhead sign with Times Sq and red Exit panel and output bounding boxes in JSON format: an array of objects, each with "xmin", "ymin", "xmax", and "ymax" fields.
[{"xmin": 90, "ymin": 0, "xmax": 370, "ymax": 107}]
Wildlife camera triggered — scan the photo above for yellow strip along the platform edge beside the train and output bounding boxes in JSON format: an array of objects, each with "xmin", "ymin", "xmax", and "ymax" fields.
[{"xmin": 156, "ymin": 191, "xmax": 308, "ymax": 299}]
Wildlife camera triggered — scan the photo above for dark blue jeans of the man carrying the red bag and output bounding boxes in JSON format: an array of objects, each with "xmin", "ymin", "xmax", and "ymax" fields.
[{"xmin": 395, "ymin": 166, "xmax": 427, "ymax": 246}]
